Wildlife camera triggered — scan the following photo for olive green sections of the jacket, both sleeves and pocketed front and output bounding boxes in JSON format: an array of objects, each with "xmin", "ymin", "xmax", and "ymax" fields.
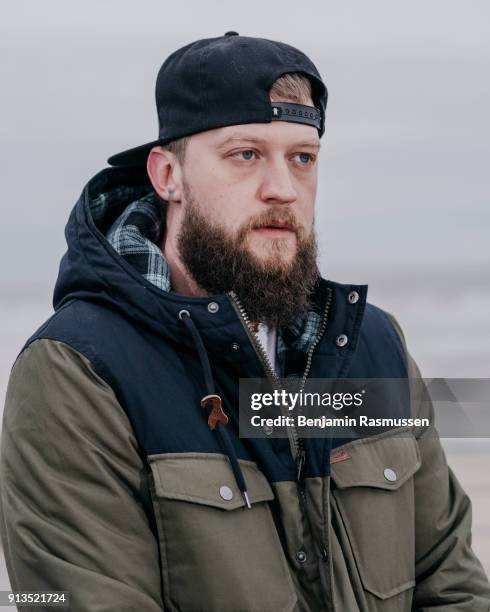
[{"xmin": 1, "ymin": 314, "xmax": 490, "ymax": 612}]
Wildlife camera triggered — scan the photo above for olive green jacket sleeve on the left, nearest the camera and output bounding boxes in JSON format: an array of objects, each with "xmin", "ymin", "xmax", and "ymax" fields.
[{"xmin": 0, "ymin": 339, "xmax": 163, "ymax": 612}]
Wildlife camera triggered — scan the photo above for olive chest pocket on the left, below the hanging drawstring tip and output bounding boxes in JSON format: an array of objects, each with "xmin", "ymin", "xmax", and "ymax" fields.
[{"xmin": 148, "ymin": 453, "xmax": 297, "ymax": 612}]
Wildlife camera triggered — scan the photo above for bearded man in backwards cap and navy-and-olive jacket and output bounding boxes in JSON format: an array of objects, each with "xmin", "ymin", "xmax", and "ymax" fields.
[{"xmin": 1, "ymin": 32, "xmax": 490, "ymax": 612}]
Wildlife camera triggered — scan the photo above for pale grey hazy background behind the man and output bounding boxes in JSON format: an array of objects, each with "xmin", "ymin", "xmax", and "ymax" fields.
[{"xmin": 0, "ymin": 0, "xmax": 490, "ymax": 588}]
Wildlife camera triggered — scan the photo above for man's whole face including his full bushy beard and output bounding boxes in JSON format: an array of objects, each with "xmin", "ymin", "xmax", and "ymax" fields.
[{"xmin": 167, "ymin": 114, "xmax": 319, "ymax": 326}]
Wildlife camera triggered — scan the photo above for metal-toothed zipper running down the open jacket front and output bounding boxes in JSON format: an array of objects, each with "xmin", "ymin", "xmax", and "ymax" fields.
[{"xmin": 228, "ymin": 287, "xmax": 332, "ymax": 482}]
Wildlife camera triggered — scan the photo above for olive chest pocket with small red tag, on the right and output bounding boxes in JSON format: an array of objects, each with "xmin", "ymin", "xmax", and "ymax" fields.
[{"xmin": 332, "ymin": 431, "xmax": 421, "ymax": 612}]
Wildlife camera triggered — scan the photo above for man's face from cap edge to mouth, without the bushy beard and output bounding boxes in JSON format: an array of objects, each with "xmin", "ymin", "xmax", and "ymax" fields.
[{"xmin": 179, "ymin": 121, "xmax": 319, "ymax": 267}]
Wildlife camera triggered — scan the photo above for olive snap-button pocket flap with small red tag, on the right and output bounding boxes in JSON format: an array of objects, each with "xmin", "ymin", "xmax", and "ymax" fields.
[{"xmin": 331, "ymin": 431, "xmax": 421, "ymax": 489}]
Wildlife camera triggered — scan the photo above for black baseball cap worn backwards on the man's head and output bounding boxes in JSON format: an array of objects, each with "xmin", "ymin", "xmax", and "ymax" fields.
[{"xmin": 107, "ymin": 32, "xmax": 328, "ymax": 166}]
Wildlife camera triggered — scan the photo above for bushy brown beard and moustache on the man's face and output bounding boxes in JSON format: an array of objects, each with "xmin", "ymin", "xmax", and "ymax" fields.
[{"xmin": 177, "ymin": 182, "xmax": 319, "ymax": 327}]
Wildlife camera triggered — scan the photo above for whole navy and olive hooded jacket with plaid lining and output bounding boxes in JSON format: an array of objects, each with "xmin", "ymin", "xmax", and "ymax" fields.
[{"xmin": 1, "ymin": 168, "xmax": 490, "ymax": 612}]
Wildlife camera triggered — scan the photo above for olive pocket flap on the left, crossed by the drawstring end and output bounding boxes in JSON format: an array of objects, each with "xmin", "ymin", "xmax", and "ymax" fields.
[{"xmin": 148, "ymin": 453, "xmax": 274, "ymax": 510}]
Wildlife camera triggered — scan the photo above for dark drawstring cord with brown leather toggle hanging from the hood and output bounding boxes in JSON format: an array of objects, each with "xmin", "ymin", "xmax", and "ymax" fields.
[{"xmin": 179, "ymin": 310, "xmax": 252, "ymax": 508}]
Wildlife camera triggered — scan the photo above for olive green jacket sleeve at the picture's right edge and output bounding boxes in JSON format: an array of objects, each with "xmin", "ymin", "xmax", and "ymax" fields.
[{"xmin": 390, "ymin": 315, "xmax": 490, "ymax": 612}]
